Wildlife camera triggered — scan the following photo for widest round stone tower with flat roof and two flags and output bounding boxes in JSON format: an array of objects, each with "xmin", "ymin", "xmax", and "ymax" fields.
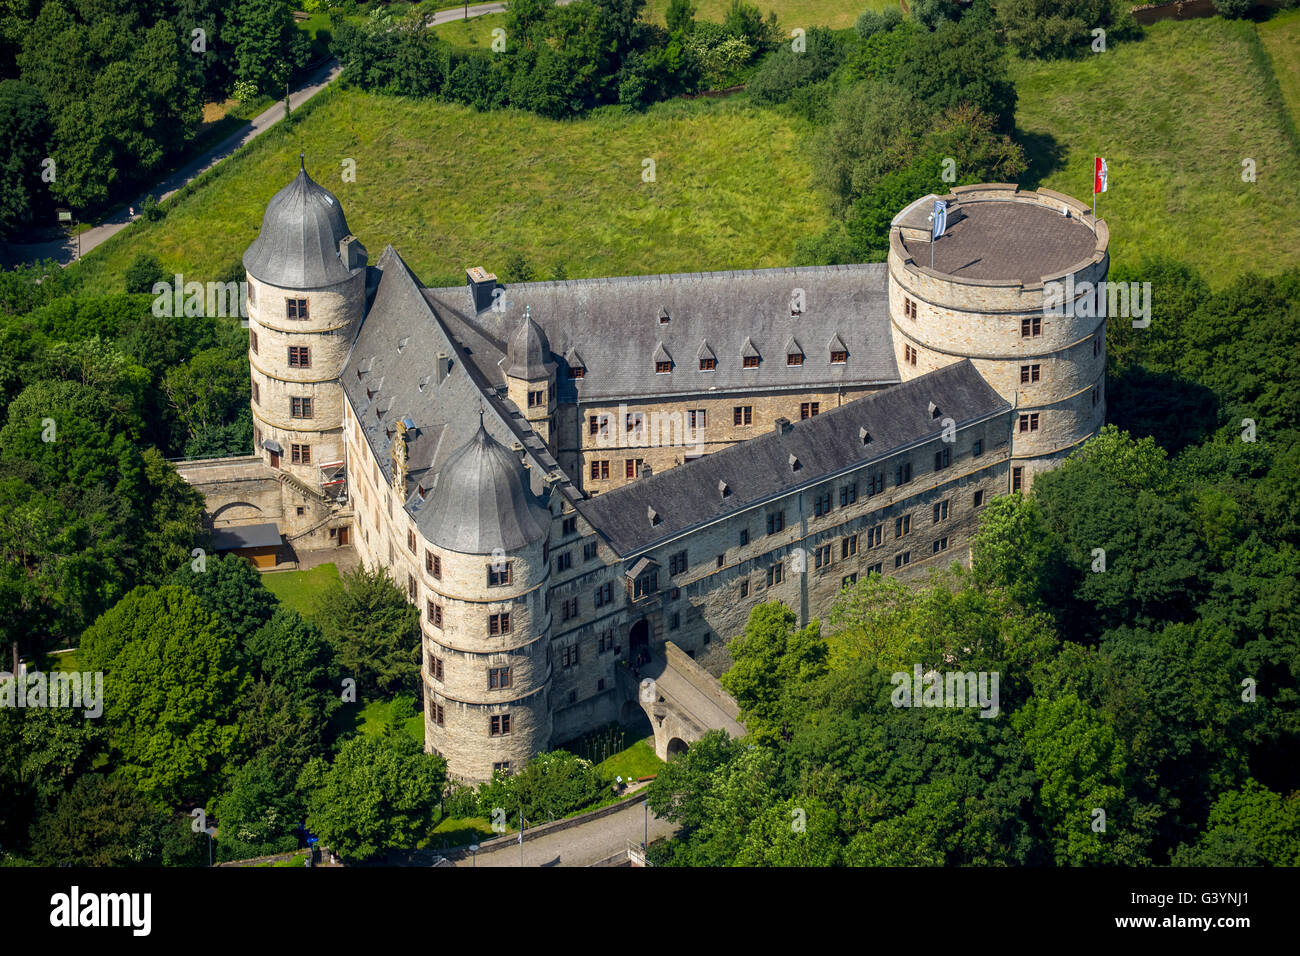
[{"xmin": 889, "ymin": 183, "xmax": 1110, "ymax": 490}]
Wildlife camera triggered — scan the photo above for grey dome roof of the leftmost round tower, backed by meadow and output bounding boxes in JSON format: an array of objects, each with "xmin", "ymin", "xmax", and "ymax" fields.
[{"xmin": 243, "ymin": 169, "xmax": 351, "ymax": 289}]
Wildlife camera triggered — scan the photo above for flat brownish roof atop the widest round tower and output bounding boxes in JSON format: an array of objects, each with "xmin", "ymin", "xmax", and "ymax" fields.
[{"xmin": 902, "ymin": 199, "xmax": 1097, "ymax": 282}]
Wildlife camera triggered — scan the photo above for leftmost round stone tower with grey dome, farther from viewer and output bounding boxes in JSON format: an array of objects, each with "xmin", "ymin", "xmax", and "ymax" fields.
[{"xmin": 243, "ymin": 160, "xmax": 365, "ymax": 490}]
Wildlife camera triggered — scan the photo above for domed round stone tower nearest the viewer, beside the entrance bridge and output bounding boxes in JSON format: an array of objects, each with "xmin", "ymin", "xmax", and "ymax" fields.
[{"xmin": 420, "ymin": 423, "xmax": 551, "ymax": 780}]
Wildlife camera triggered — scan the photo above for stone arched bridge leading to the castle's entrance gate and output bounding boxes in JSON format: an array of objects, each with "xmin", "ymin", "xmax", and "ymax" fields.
[{"xmin": 637, "ymin": 641, "xmax": 745, "ymax": 760}]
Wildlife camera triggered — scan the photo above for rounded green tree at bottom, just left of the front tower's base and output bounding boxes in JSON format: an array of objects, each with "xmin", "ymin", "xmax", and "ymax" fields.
[{"xmin": 300, "ymin": 735, "xmax": 447, "ymax": 861}]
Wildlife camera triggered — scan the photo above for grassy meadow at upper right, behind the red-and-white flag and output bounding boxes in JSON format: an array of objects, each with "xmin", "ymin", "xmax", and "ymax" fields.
[{"xmin": 1013, "ymin": 18, "xmax": 1300, "ymax": 284}]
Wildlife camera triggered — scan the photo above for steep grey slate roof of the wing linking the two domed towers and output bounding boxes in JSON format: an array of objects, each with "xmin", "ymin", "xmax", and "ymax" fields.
[{"xmin": 342, "ymin": 246, "xmax": 577, "ymax": 550}]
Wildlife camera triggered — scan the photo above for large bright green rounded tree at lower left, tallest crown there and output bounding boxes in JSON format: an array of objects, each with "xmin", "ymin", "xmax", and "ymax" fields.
[{"xmin": 81, "ymin": 585, "xmax": 248, "ymax": 805}]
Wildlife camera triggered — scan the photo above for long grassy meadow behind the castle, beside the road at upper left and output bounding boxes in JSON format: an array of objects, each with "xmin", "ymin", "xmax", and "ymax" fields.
[{"xmin": 71, "ymin": 88, "xmax": 828, "ymax": 293}]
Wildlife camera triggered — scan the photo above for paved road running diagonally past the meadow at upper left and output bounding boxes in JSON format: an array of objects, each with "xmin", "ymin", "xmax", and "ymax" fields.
[{"xmin": 0, "ymin": 0, "xmax": 553, "ymax": 265}]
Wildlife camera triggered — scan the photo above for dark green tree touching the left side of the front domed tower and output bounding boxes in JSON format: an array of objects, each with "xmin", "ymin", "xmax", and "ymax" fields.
[{"xmin": 313, "ymin": 567, "xmax": 420, "ymax": 696}]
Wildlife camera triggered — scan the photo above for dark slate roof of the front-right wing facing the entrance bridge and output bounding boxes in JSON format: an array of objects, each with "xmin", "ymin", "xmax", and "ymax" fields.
[{"xmin": 577, "ymin": 359, "xmax": 1010, "ymax": 557}]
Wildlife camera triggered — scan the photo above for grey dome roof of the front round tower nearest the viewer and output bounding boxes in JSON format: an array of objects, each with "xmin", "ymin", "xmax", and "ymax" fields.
[{"xmin": 420, "ymin": 424, "xmax": 551, "ymax": 554}]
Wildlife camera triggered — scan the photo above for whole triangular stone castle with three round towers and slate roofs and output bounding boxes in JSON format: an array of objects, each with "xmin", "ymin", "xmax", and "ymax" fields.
[{"xmin": 181, "ymin": 170, "xmax": 1109, "ymax": 780}]
